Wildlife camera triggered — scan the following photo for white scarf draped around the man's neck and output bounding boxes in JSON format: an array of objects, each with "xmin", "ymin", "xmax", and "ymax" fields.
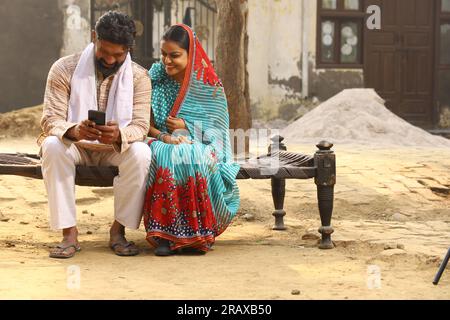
[{"xmin": 67, "ymin": 43, "xmax": 134, "ymax": 128}]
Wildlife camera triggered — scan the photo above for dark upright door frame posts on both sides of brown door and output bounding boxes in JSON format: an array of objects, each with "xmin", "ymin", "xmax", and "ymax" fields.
[{"xmin": 363, "ymin": 0, "xmax": 441, "ymax": 127}]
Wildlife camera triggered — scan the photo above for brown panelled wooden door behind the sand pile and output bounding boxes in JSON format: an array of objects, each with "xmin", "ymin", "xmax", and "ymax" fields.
[{"xmin": 364, "ymin": 0, "xmax": 435, "ymax": 128}]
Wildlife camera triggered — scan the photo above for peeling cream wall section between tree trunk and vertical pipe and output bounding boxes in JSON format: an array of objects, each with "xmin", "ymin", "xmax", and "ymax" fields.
[{"xmin": 248, "ymin": 0, "xmax": 301, "ymax": 118}]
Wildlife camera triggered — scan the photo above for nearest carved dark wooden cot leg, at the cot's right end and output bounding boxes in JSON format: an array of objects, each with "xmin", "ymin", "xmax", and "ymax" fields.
[{"xmin": 314, "ymin": 141, "xmax": 336, "ymax": 249}]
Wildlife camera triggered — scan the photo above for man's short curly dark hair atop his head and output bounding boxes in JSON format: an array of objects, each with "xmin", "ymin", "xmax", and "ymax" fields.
[{"xmin": 95, "ymin": 11, "xmax": 136, "ymax": 48}]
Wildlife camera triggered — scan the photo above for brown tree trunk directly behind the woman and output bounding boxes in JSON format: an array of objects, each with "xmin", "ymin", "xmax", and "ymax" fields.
[{"xmin": 215, "ymin": 0, "xmax": 252, "ymax": 154}]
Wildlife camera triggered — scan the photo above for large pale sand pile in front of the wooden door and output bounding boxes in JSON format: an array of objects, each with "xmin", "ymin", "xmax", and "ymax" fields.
[{"xmin": 282, "ymin": 89, "xmax": 450, "ymax": 148}]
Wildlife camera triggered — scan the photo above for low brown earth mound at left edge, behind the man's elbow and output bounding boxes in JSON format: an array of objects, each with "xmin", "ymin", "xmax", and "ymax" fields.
[{"xmin": 0, "ymin": 105, "xmax": 42, "ymax": 139}]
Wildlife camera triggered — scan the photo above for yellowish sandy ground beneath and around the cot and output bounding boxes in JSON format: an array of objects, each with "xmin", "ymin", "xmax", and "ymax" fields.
[{"xmin": 0, "ymin": 138, "xmax": 450, "ymax": 299}]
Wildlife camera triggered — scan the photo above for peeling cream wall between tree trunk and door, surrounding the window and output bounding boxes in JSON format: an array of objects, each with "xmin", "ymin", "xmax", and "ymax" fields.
[{"xmin": 248, "ymin": 0, "xmax": 364, "ymax": 119}]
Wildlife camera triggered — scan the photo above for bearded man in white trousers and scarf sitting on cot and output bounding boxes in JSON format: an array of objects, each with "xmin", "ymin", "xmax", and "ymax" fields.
[{"xmin": 39, "ymin": 11, "xmax": 151, "ymax": 258}]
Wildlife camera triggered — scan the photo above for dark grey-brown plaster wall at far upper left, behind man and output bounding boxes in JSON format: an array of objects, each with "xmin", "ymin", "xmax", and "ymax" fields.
[{"xmin": 0, "ymin": 0, "xmax": 64, "ymax": 112}]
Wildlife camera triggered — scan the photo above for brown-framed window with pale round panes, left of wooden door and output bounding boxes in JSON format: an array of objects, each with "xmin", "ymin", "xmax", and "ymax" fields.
[{"xmin": 317, "ymin": 0, "xmax": 365, "ymax": 68}]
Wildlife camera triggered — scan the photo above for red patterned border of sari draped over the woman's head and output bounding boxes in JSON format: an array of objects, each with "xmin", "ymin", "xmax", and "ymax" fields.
[{"xmin": 169, "ymin": 23, "xmax": 222, "ymax": 117}]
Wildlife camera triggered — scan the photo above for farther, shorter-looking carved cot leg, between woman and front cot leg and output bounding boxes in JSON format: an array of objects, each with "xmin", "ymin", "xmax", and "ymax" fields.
[{"xmin": 269, "ymin": 135, "xmax": 287, "ymax": 231}]
